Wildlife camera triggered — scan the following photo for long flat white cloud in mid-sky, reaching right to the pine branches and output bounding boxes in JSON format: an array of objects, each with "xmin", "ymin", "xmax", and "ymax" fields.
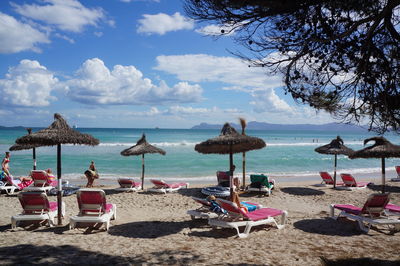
[{"xmin": 155, "ymin": 54, "xmax": 283, "ymax": 88}]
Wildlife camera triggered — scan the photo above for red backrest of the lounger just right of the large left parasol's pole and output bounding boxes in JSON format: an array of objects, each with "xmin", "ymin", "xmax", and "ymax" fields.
[{"xmin": 76, "ymin": 189, "xmax": 107, "ymax": 214}]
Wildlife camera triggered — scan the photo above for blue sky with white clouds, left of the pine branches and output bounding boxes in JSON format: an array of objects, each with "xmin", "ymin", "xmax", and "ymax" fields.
[{"xmin": 0, "ymin": 0, "xmax": 334, "ymax": 128}]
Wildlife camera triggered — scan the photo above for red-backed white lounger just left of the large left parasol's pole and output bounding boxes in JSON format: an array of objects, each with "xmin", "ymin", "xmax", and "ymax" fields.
[{"xmin": 11, "ymin": 191, "xmax": 65, "ymax": 229}]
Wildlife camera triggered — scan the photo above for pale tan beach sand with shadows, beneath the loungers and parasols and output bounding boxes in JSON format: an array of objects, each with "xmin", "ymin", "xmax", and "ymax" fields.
[{"xmin": 0, "ymin": 182, "xmax": 400, "ymax": 265}]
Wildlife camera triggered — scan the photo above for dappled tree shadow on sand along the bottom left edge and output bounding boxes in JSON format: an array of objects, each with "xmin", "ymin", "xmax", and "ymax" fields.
[{"xmin": 0, "ymin": 245, "xmax": 205, "ymax": 265}]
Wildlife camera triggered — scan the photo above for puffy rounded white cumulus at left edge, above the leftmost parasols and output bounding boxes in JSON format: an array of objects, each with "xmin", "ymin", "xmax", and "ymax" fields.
[{"xmin": 0, "ymin": 59, "xmax": 58, "ymax": 107}]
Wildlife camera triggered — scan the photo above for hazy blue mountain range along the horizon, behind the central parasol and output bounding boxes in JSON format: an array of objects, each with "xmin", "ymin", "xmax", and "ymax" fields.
[{"xmin": 191, "ymin": 121, "xmax": 367, "ymax": 132}]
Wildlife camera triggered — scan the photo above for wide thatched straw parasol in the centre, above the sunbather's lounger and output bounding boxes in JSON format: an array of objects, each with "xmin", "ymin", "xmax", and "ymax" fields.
[{"xmin": 194, "ymin": 123, "xmax": 266, "ymax": 198}]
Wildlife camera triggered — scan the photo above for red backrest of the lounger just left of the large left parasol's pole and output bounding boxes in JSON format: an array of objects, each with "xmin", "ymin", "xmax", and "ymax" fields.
[{"xmin": 18, "ymin": 191, "xmax": 50, "ymax": 213}]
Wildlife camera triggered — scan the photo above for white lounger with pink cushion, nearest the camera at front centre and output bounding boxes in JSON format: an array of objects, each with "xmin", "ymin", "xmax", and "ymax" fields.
[{"xmin": 208, "ymin": 199, "xmax": 287, "ymax": 238}]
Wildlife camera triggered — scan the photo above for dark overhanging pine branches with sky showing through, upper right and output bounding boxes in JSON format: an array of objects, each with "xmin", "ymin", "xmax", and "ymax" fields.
[{"xmin": 184, "ymin": 0, "xmax": 400, "ymax": 133}]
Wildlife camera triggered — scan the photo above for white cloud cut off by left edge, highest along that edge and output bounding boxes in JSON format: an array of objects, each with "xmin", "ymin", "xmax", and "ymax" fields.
[{"xmin": 0, "ymin": 12, "xmax": 50, "ymax": 54}]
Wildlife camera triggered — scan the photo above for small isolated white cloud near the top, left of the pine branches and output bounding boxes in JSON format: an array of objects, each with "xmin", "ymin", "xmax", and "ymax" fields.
[{"xmin": 137, "ymin": 12, "xmax": 194, "ymax": 35}]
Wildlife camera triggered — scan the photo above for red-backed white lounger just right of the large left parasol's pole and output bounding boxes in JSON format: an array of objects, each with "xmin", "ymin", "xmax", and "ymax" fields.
[{"xmin": 69, "ymin": 188, "xmax": 117, "ymax": 231}]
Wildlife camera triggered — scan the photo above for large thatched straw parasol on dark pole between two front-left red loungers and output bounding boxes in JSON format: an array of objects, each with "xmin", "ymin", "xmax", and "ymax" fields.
[{"xmin": 15, "ymin": 113, "xmax": 99, "ymax": 225}]
